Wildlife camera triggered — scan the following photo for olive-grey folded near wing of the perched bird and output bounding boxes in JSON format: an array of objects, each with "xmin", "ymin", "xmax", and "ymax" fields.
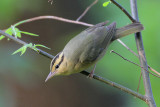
[{"xmin": 80, "ymin": 23, "xmax": 116, "ymax": 63}]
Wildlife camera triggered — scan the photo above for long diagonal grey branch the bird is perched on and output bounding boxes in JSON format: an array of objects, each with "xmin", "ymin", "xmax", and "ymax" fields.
[{"xmin": 0, "ymin": 30, "xmax": 147, "ymax": 102}]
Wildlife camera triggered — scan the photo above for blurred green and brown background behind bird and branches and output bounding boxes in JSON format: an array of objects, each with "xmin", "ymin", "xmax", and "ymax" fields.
[{"xmin": 0, "ymin": 0, "xmax": 160, "ymax": 107}]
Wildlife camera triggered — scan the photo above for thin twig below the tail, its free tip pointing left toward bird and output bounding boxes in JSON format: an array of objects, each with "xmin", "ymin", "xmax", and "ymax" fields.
[{"xmin": 110, "ymin": 50, "xmax": 160, "ymax": 78}]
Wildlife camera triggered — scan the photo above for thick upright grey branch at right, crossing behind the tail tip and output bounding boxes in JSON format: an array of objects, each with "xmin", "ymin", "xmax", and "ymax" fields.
[{"xmin": 130, "ymin": 0, "xmax": 156, "ymax": 107}]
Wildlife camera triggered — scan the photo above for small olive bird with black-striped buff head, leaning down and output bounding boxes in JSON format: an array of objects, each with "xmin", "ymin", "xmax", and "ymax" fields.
[{"xmin": 45, "ymin": 22, "xmax": 143, "ymax": 81}]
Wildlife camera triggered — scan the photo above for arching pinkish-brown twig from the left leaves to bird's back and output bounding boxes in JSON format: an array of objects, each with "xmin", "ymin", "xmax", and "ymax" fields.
[{"xmin": 13, "ymin": 16, "xmax": 93, "ymax": 26}]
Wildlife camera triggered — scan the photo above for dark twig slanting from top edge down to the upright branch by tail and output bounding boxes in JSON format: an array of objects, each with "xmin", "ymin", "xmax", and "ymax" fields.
[{"xmin": 110, "ymin": 0, "xmax": 136, "ymax": 22}]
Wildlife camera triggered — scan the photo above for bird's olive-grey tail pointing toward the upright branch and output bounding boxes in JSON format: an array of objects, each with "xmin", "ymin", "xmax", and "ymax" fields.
[{"xmin": 112, "ymin": 22, "xmax": 144, "ymax": 41}]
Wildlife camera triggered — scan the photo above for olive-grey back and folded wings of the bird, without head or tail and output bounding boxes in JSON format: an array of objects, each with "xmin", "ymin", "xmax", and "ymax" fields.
[{"xmin": 63, "ymin": 23, "xmax": 116, "ymax": 69}]
